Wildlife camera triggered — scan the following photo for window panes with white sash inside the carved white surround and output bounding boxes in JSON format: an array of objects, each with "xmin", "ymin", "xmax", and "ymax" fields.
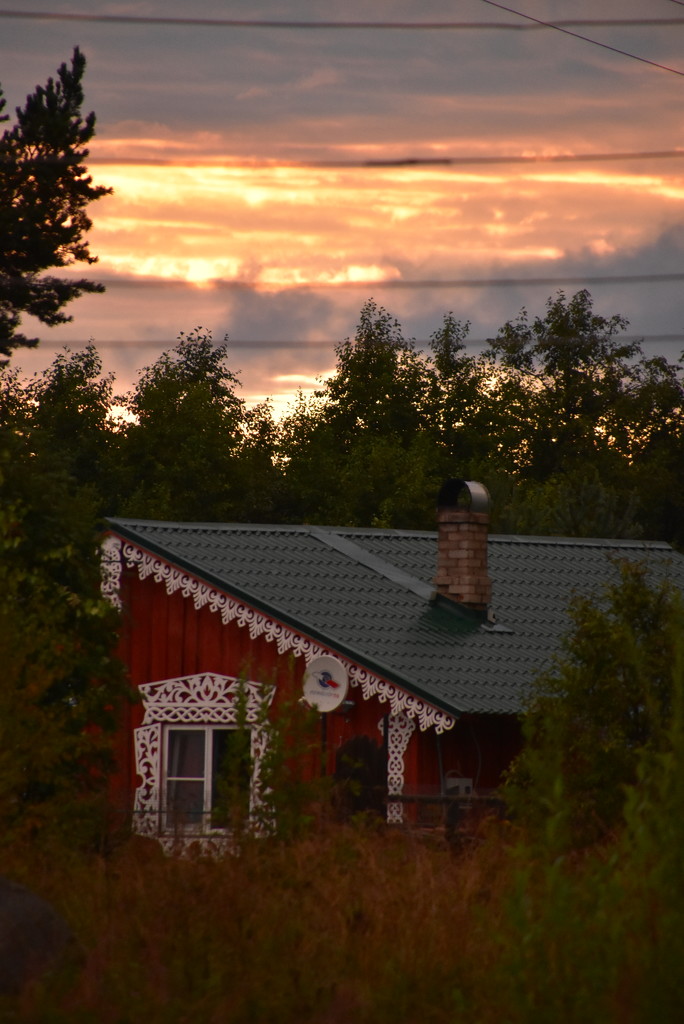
[{"xmin": 163, "ymin": 726, "xmax": 252, "ymax": 833}]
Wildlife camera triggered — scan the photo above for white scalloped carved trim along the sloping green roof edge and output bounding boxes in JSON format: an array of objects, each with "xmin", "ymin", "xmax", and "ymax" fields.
[{"xmin": 123, "ymin": 542, "xmax": 456, "ymax": 733}]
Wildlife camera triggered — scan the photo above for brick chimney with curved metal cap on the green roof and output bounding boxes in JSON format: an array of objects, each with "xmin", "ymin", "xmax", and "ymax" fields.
[{"xmin": 434, "ymin": 480, "xmax": 491, "ymax": 612}]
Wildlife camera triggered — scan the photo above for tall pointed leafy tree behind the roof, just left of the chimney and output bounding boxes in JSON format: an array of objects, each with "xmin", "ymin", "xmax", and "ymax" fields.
[{"xmin": 280, "ymin": 300, "xmax": 446, "ymax": 527}]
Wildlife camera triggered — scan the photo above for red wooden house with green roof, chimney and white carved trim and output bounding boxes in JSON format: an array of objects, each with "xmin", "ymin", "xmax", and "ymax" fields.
[{"xmin": 102, "ymin": 480, "xmax": 684, "ymax": 845}]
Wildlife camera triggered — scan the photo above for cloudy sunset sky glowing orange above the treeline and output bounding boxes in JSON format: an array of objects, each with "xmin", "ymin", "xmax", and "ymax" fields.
[{"xmin": 0, "ymin": 0, "xmax": 684, "ymax": 412}]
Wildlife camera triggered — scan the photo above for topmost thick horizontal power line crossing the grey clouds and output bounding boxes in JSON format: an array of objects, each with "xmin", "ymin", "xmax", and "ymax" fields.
[{"xmin": 0, "ymin": 4, "xmax": 684, "ymax": 29}]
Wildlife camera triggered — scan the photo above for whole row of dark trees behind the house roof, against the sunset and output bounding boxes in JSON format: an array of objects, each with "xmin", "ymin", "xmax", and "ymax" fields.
[{"xmin": 5, "ymin": 292, "xmax": 684, "ymax": 544}]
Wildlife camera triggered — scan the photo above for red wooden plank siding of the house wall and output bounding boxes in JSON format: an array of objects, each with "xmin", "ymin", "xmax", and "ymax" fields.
[{"xmin": 113, "ymin": 557, "xmax": 520, "ymax": 818}]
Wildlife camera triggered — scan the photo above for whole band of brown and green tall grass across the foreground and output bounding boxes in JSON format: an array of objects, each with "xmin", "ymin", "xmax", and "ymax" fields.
[{"xmin": 0, "ymin": 802, "xmax": 684, "ymax": 1024}]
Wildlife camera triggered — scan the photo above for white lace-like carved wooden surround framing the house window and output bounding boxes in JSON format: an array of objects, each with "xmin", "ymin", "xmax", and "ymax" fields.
[{"xmin": 133, "ymin": 673, "xmax": 275, "ymax": 852}]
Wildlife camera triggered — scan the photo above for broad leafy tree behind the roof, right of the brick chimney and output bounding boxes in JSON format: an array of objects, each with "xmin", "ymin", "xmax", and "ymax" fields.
[{"xmin": 485, "ymin": 291, "xmax": 684, "ymax": 543}]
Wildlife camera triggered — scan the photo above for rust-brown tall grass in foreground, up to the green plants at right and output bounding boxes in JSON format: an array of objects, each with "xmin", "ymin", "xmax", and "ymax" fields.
[{"xmin": 1, "ymin": 825, "xmax": 507, "ymax": 1024}]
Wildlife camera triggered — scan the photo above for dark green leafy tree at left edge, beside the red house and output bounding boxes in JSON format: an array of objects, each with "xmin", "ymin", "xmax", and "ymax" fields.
[{"xmin": 0, "ymin": 346, "xmax": 126, "ymax": 843}]
